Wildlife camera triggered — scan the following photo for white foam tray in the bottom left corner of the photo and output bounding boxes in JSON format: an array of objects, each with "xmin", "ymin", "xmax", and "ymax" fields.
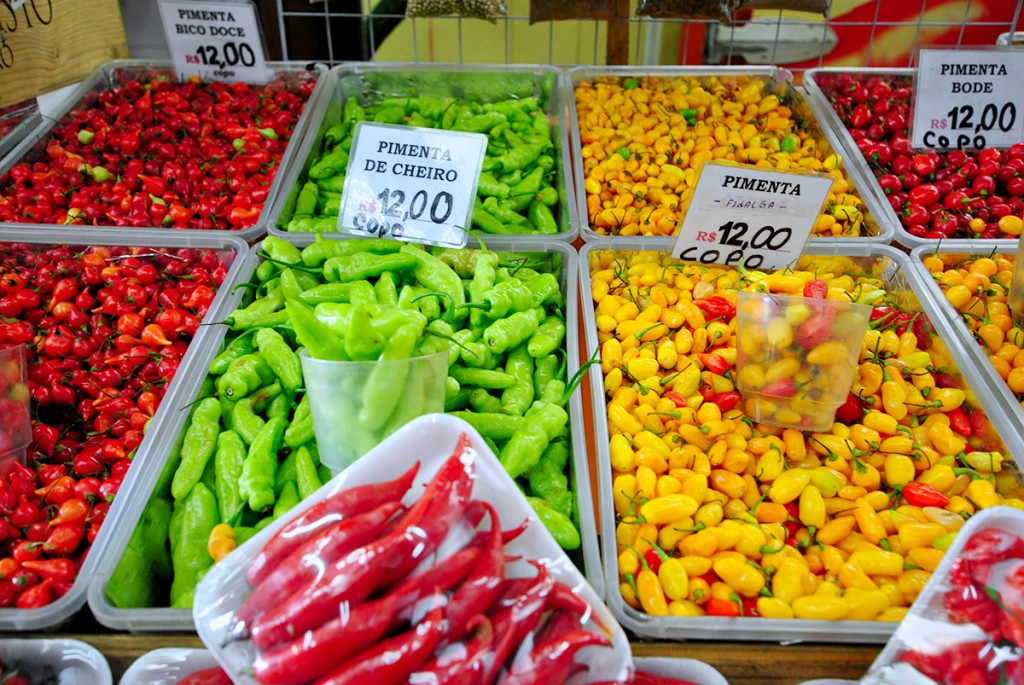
[{"xmin": 0, "ymin": 638, "xmax": 113, "ymax": 685}]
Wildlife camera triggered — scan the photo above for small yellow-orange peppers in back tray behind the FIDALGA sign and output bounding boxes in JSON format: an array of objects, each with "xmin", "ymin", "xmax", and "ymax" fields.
[{"xmin": 574, "ymin": 76, "xmax": 864, "ymax": 237}]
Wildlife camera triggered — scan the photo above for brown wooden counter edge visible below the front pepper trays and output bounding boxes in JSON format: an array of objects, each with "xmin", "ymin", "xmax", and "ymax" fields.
[{"xmin": 12, "ymin": 608, "xmax": 883, "ymax": 685}]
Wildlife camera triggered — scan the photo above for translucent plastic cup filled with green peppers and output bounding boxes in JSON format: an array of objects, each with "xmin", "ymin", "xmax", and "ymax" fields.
[{"xmin": 299, "ymin": 349, "xmax": 449, "ymax": 474}]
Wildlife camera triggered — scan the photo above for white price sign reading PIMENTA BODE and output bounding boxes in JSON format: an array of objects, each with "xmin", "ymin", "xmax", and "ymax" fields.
[{"xmin": 911, "ymin": 49, "xmax": 1024, "ymax": 149}]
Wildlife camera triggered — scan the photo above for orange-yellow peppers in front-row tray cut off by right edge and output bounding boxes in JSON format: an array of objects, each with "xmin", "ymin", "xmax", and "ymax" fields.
[{"xmin": 923, "ymin": 254, "xmax": 1024, "ymax": 406}]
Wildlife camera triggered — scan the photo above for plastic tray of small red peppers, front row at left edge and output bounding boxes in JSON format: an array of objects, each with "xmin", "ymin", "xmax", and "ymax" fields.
[{"xmin": 0, "ymin": 226, "xmax": 248, "ymax": 630}]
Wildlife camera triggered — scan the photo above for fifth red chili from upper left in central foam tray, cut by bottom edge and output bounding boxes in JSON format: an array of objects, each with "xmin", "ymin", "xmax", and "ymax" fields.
[{"xmin": 307, "ymin": 608, "xmax": 444, "ymax": 685}]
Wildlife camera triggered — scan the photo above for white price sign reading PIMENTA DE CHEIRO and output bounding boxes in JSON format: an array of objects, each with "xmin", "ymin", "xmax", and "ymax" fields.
[{"xmin": 338, "ymin": 122, "xmax": 487, "ymax": 248}]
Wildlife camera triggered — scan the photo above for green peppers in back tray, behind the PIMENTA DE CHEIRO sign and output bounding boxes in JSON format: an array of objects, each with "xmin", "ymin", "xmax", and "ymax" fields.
[{"xmin": 278, "ymin": 90, "xmax": 561, "ymax": 234}]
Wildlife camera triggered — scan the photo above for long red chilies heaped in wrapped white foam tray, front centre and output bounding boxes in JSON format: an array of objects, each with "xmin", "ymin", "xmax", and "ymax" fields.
[{"xmin": 233, "ymin": 435, "xmax": 609, "ymax": 685}]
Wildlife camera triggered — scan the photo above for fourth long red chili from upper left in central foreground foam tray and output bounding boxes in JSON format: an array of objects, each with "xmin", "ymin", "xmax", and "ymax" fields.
[{"xmin": 254, "ymin": 549, "xmax": 481, "ymax": 685}]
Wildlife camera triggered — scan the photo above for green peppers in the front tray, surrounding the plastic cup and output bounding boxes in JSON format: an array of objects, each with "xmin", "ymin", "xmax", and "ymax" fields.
[{"xmin": 106, "ymin": 237, "xmax": 581, "ymax": 607}]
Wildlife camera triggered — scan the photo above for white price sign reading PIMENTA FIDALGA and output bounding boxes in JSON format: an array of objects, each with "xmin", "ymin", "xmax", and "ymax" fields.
[{"xmin": 672, "ymin": 162, "xmax": 834, "ymax": 270}]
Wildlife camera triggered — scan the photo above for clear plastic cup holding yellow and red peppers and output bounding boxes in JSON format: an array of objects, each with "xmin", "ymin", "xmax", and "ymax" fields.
[{"xmin": 736, "ymin": 291, "xmax": 871, "ymax": 431}]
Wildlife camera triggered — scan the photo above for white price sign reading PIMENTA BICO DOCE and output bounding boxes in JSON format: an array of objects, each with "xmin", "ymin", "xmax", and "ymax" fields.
[{"xmin": 160, "ymin": 0, "xmax": 267, "ymax": 83}]
